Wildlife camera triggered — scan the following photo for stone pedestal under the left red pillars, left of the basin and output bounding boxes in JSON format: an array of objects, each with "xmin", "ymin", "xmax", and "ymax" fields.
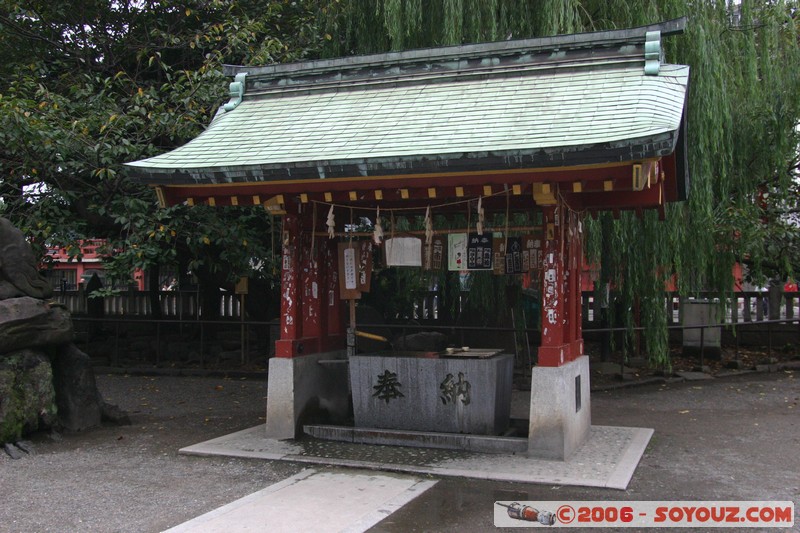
[{"xmin": 267, "ymin": 351, "xmax": 349, "ymax": 439}]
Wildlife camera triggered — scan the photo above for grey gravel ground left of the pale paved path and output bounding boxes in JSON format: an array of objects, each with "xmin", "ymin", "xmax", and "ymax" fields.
[{"xmin": 0, "ymin": 375, "xmax": 302, "ymax": 533}]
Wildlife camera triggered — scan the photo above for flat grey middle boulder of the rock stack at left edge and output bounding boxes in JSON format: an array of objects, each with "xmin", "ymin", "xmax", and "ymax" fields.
[{"xmin": 0, "ymin": 296, "xmax": 73, "ymax": 355}]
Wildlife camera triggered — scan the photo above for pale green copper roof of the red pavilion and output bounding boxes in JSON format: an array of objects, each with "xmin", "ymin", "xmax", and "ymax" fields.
[{"xmin": 128, "ymin": 19, "xmax": 689, "ymax": 183}]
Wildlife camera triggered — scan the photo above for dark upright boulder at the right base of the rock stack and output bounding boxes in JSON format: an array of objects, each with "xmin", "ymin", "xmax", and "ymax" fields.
[{"xmin": 53, "ymin": 344, "xmax": 101, "ymax": 431}]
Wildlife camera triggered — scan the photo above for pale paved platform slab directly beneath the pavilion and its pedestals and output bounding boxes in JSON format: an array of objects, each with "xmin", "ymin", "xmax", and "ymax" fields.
[{"xmin": 180, "ymin": 425, "xmax": 653, "ymax": 490}]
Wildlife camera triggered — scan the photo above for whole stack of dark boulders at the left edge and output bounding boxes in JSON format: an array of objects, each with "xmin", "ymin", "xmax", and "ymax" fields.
[{"xmin": 0, "ymin": 217, "xmax": 129, "ymax": 448}]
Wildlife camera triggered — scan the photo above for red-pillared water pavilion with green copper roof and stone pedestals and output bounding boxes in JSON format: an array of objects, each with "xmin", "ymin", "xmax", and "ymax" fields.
[{"xmin": 127, "ymin": 19, "xmax": 689, "ymax": 459}]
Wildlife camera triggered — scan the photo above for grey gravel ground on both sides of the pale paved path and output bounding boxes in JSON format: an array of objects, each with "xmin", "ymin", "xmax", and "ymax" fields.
[{"xmin": 0, "ymin": 370, "xmax": 800, "ymax": 533}]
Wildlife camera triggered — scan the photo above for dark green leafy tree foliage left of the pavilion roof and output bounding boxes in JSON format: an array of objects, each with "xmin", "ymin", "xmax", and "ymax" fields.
[{"xmin": 0, "ymin": 0, "xmax": 318, "ymax": 308}]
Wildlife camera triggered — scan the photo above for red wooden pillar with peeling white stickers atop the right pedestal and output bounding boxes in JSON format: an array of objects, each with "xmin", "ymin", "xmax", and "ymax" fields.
[{"xmin": 539, "ymin": 205, "xmax": 577, "ymax": 367}]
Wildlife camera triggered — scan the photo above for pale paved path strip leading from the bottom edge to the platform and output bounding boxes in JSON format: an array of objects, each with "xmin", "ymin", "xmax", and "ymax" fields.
[{"xmin": 167, "ymin": 468, "xmax": 436, "ymax": 533}]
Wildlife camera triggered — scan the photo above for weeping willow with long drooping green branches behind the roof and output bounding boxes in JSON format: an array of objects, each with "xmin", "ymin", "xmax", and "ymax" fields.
[{"xmin": 320, "ymin": 0, "xmax": 800, "ymax": 366}]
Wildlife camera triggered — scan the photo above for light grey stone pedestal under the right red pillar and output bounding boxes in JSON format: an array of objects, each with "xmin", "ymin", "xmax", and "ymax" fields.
[{"xmin": 528, "ymin": 355, "xmax": 592, "ymax": 461}]
